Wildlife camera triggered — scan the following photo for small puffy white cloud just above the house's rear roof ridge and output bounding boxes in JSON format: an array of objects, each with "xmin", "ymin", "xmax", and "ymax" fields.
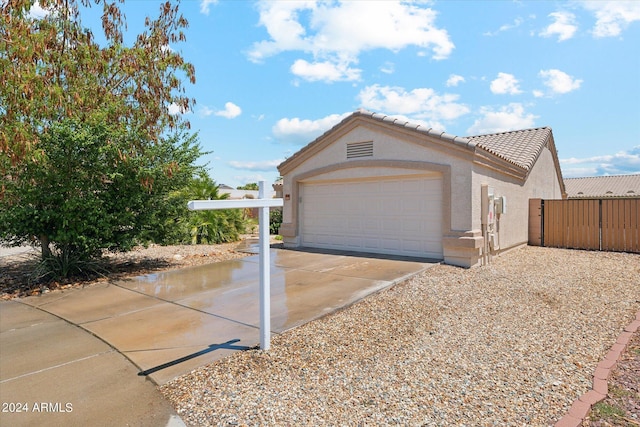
[{"xmin": 467, "ymin": 103, "xmax": 537, "ymax": 135}]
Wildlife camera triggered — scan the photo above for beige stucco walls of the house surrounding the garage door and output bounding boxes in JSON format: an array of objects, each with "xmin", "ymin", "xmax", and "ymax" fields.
[{"xmin": 280, "ymin": 121, "xmax": 562, "ymax": 267}]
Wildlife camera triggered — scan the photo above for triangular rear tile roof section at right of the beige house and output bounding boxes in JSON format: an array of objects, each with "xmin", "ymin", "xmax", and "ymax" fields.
[{"xmin": 467, "ymin": 127, "xmax": 551, "ymax": 171}]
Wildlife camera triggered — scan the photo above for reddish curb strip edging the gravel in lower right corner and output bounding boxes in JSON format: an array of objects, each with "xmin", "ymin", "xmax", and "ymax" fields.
[{"xmin": 555, "ymin": 310, "xmax": 640, "ymax": 427}]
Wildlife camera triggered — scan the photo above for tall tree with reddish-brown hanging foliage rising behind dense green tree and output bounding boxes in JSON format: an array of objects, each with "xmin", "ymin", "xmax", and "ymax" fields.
[{"xmin": 0, "ymin": 0, "xmax": 195, "ymax": 176}]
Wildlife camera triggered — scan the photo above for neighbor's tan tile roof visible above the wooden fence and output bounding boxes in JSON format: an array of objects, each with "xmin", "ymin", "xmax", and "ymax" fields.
[{"xmin": 564, "ymin": 174, "xmax": 640, "ymax": 199}]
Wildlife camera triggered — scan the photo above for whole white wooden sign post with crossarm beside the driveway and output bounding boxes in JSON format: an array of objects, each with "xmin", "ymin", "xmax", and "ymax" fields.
[{"xmin": 187, "ymin": 181, "xmax": 284, "ymax": 350}]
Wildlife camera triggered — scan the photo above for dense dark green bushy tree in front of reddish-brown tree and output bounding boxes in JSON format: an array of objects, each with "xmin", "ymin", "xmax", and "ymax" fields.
[{"xmin": 0, "ymin": 119, "xmax": 202, "ymax": 277}]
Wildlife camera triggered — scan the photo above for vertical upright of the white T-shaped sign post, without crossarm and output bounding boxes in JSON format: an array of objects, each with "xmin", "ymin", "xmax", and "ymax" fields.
[{"xmin": 258, "ymin": 181, "xmax": 271, "ymax": 350}]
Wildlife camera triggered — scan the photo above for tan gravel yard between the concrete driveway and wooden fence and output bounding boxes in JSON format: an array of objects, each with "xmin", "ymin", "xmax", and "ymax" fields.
[{"xmin": 161, "ymin": 247, "xmax": 640, "ymax": 426}]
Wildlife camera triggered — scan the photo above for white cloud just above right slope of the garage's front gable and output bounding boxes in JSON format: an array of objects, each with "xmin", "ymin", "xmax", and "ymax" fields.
[{"xmin": 358, "ymin": 84, "xmax": 470, "ymax": 126}]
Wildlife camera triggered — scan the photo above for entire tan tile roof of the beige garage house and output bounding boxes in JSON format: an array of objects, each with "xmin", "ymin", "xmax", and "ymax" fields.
[{"xmin": 278, "ymin": 109, "xmax": 565, "ymax": 194}]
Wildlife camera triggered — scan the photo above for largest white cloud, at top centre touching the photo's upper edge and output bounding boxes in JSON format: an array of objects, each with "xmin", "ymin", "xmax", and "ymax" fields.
[{"xmin": 249, "ymin": 1, "xmax": 454, "ymax": 81}]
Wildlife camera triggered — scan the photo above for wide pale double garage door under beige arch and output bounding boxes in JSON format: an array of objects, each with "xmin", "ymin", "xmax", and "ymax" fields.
[{"xmin": 300, "ymin": 175, "xmax": 442, "ymax": 258}]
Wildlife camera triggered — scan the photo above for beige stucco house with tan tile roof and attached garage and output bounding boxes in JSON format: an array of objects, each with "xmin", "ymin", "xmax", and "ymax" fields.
[{"xmin": 278, "ymin": 110, "xmax": 566, "ymax": 267}]
